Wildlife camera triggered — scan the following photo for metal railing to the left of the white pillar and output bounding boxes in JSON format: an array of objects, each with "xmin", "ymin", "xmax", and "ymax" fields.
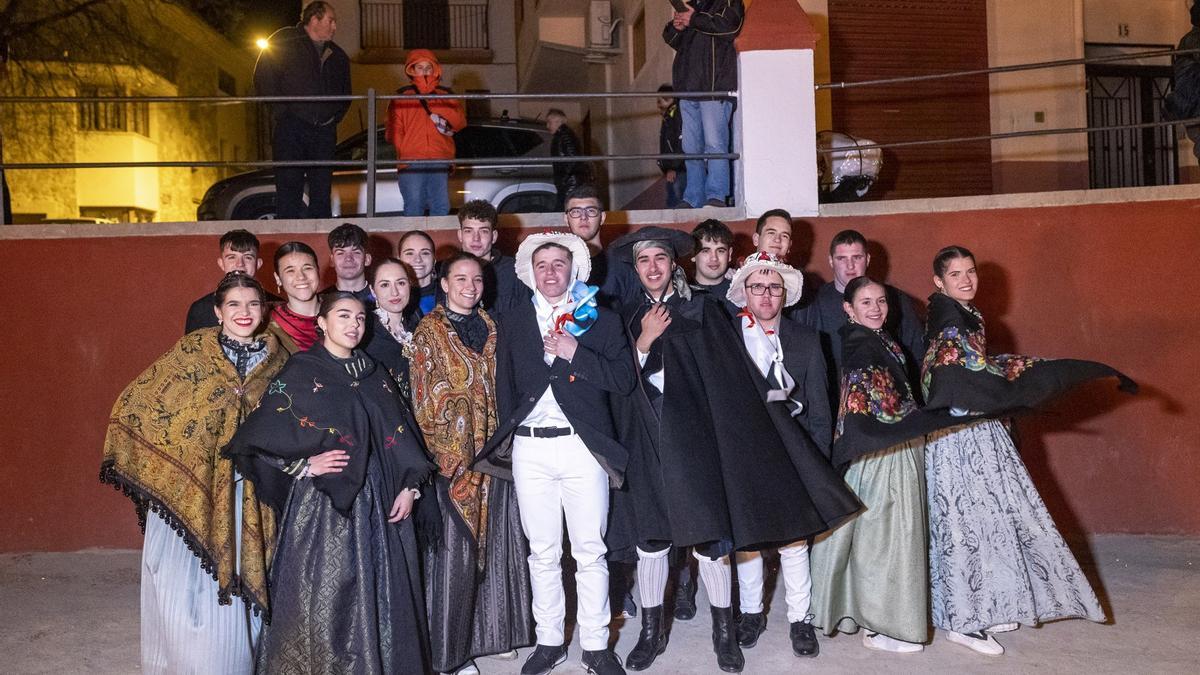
[{"xmin": 0, "ymin": 89, "xmax": 740, "ymax": 217}]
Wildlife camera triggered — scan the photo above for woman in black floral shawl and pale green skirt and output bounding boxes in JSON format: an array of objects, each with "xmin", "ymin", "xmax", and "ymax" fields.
[{"xmin": 810, "ymin": 276, "xmax": 955, "ymax": 652}]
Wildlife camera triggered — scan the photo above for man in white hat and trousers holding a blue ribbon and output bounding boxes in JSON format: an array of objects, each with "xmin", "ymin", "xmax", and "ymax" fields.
[{"xmin": 480, "ymin": 233, "xmax": 635, "ymax": 675}]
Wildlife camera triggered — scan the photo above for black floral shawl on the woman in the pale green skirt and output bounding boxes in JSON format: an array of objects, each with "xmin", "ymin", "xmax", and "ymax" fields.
[{"xmin": 833, "ymin": 323, "xmax": 965, "ymax": 467}]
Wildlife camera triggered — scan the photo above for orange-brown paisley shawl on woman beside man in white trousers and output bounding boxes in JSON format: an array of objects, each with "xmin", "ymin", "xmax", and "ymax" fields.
[{"xmin": 409, "ymin": 305, "xmax": 498, "ymax": 568}]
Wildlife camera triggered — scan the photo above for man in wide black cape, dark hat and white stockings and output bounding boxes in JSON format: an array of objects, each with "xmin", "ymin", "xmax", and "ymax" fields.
[{"xmin": 610, "ymin": 227, "xmax": 858, "ymax": 673}]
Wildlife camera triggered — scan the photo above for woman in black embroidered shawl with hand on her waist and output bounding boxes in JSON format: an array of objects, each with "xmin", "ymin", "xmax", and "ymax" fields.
[{"xmin": 224, "ymin": 292, "xmax": 438, "ymax": 673}]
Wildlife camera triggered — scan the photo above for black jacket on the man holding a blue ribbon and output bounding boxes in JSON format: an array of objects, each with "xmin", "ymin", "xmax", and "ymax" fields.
[{"xmin": 475, "ymin": 303, "xmax": 636, "ymax": 488}]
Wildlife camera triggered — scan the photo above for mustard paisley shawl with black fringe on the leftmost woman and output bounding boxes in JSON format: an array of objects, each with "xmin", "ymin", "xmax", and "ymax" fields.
[{"xmin": 100, "ymin": 328, "xmax": 287, "ymax": 613}]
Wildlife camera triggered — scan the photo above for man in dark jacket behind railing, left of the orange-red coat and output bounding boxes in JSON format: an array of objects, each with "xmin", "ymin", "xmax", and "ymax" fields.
[{"xmin": 254, "ymin": 0, "xmax": 350, "ymax": 219}]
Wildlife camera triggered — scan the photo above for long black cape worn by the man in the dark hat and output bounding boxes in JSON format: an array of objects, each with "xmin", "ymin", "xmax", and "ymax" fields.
[{"xmin": 608, "ymin": 297, "xmax": 858, "ymax": 550}]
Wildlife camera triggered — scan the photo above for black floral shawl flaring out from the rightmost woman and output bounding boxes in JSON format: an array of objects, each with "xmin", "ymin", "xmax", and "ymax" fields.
[{"xmin": 920, "ymin": 293, "xmax": 1138, "ymax": 417}]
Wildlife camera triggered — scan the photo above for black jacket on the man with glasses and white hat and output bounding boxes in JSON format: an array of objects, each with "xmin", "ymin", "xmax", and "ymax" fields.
[{"xmin": 733, "ymin": 317, "xmax": 833, "ymax": 459}]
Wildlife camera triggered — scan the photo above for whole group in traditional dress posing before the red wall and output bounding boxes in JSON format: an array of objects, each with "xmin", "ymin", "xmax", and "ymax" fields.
[{"xmin": 101, "ymin": 185, "xmax": 1135, "ymax": 675}]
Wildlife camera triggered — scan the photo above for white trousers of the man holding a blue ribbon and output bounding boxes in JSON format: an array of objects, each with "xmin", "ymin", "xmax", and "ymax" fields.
[{"xmin": 512, "ymin": 434, "xmax": 612, "ymax": 651}]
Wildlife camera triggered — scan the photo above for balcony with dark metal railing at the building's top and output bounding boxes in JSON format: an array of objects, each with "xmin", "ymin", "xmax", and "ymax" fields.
[{"xmin": 359, "ymin": 0, "xmax": 488, "ymax": 49}]
